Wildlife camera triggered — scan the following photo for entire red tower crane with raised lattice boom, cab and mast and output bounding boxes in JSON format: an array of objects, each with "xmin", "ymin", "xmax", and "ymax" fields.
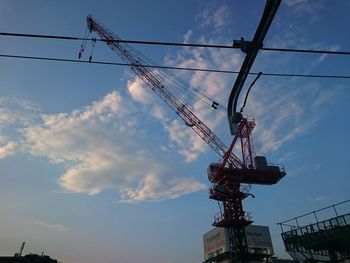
[{"xmin": 85, "ymin": 6, "xmax": 285, "ymax": 261}]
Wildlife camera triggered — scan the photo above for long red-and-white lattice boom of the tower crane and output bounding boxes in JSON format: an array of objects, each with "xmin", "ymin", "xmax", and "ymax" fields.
[{"xmin": 86, "ymin": 16, "xmax": 245, "ymax": 168}]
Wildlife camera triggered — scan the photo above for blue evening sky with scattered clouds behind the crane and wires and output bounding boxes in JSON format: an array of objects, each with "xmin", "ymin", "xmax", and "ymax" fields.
[{"xmin": 0, "ymin": 0, "xmax": 350, "ymax": 263}]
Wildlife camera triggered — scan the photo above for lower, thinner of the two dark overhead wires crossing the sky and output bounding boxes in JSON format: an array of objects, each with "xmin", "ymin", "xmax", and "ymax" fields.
[{"xmin": 0, "ymin": 54, "xmax": 350, "ymax": 79}]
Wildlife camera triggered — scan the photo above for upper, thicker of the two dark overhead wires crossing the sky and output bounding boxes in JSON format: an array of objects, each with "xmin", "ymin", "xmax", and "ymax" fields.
[{"xmin": 0, "ymin": 32, "xmax": 350, "ymax": 55}]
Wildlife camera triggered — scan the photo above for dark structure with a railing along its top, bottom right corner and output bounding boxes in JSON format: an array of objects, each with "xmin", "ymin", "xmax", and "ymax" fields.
[{"xmin": 278, "ymin": 200, "xmax": 350, "ymax": 262}]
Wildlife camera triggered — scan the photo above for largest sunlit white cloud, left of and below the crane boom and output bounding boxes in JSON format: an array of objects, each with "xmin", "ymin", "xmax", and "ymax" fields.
[{"xmin": 23, "ymin": 92, "xmax": 204, "ymax": 203}]
